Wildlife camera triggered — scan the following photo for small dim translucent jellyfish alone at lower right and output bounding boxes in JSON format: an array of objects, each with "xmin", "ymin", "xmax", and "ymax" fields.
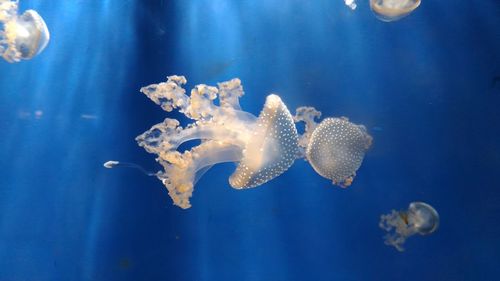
[{"xmin": 379, "ymin": 202, "xmax": 439, "ymax": 249}]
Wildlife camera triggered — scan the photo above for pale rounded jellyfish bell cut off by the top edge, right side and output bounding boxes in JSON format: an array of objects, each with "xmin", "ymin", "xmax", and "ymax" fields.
[{"xmin": 370, "ymin": 0, "xmax": 420, "ymax": 22}]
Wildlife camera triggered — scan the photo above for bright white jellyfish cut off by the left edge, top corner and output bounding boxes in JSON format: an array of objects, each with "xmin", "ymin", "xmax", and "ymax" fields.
[{"xmin": 0, "ymin": 0, "xmax": 50, "ymax": 63}]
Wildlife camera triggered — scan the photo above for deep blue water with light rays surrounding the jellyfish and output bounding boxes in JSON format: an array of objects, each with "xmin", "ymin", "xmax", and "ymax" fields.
[{"xmin": 0, "ymin": 0, "xmax": 500, "ymax": 281}]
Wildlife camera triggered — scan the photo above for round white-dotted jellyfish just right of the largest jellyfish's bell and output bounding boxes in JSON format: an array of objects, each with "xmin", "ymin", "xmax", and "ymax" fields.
[{"xmin": 295, "ymin": 107, "xmax": 372, "ymax": 187}]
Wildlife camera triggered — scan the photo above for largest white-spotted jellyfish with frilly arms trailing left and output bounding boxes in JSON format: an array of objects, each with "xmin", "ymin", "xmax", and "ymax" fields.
[{"xmin": 137, "ymin": 76, "xmax": 298, "ymax": 208}]
